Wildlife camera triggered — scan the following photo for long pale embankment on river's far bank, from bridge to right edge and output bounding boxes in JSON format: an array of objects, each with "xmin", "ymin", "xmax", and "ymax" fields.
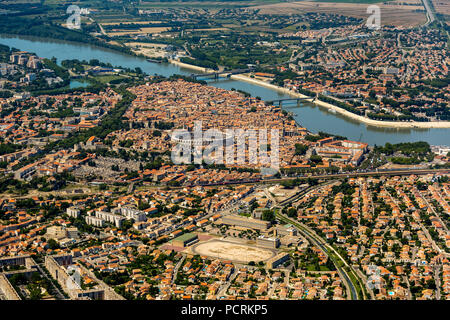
[{"xmin": 230, "ymin": 75, "xmax": 450, "ymax": 129}]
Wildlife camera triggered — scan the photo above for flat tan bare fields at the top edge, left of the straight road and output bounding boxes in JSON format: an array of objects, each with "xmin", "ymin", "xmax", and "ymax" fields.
[{"xmin": 252, "ymin": 0, "xmax": 428, "ymax": 26}]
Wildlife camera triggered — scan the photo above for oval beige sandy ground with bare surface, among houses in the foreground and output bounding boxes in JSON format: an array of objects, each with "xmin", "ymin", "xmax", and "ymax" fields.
[{"xmin": 192, "ymin": 240, "xmax": 275, "ymax": 263}]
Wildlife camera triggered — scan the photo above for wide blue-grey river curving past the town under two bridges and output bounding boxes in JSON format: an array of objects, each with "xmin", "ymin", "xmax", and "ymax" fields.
[{"xmin": 0, "ymin": 35, "xmax": 450, "ymax": 145}]
